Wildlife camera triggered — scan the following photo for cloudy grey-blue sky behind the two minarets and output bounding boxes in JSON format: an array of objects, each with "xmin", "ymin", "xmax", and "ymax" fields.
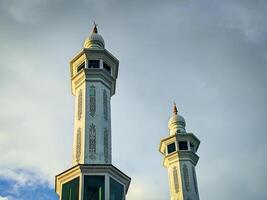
[{"xmin": 0, "ymin": 0, "xmax": 267, "ymax": 200}]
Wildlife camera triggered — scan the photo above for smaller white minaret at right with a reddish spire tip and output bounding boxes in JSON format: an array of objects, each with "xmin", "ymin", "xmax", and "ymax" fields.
[{"xmin": 159, "ymin": 104, "xmax": 200, "ymax": 200}]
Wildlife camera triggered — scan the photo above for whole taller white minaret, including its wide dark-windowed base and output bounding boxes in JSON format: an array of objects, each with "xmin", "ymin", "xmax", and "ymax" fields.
[{"xmin": 55, "ymin": 24, "xmax": 131, "ymax": 200}]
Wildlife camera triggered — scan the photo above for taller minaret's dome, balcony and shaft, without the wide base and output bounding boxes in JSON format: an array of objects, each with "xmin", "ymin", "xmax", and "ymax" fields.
[{"xmin": 71, "ymin": 26, "xmax": 119, "ymax": 165}]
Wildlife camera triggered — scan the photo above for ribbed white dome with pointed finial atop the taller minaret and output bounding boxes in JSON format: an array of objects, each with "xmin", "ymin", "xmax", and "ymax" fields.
[{"xmin": 83, "ymin": 24, "xmax": 105, "ymax": 49}]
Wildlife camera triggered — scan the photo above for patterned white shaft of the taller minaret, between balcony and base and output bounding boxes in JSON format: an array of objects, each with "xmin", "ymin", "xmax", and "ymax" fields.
[{"xmin": 73, "ymin": 77, "xmax": 111, "ymax": 165}]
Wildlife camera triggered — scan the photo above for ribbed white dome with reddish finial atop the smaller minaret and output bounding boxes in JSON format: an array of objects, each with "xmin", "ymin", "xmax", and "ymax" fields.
[{"xmin": 168, "ymin": 103, "xmax": 186, "ymax": 135}]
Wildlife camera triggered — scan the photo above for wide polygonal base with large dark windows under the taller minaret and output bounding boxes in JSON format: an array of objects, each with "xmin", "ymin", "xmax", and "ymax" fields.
[{"xmin": 55, "ymin": 164, "xmax": 131, "ymax": 200}]
